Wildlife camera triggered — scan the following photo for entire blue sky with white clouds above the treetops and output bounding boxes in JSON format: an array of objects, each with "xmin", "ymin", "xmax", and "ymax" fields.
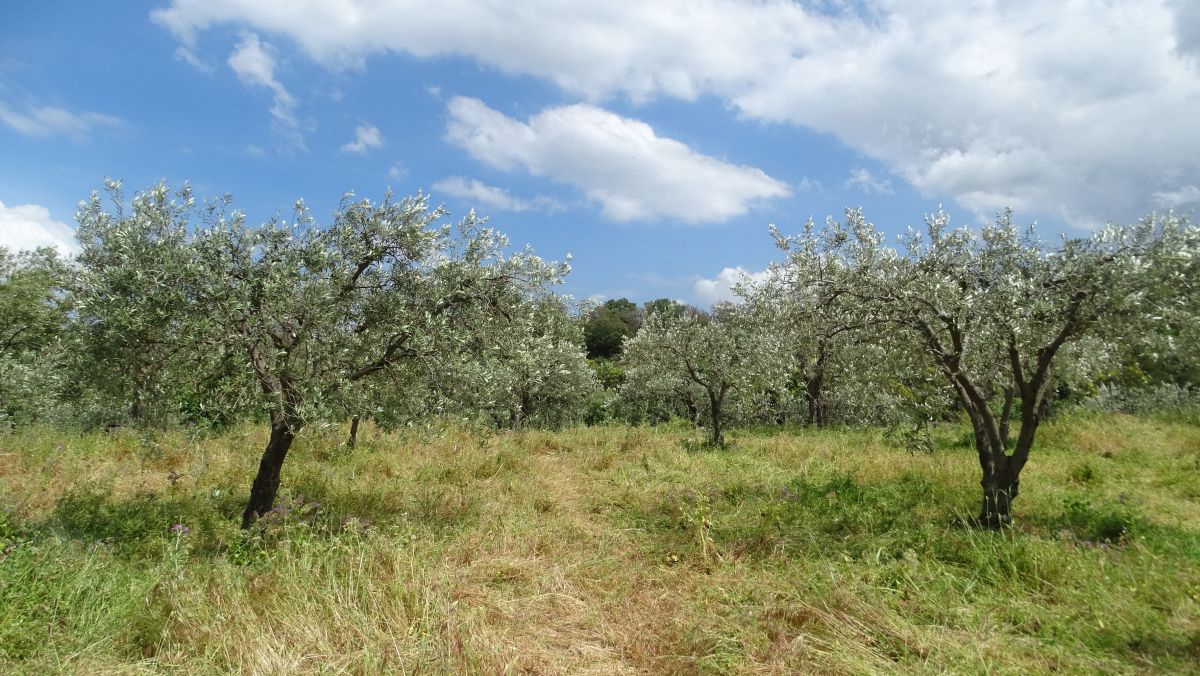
[{"xmin": 0, "ymin": 0, "xmax": 1200, "ymax": 305}]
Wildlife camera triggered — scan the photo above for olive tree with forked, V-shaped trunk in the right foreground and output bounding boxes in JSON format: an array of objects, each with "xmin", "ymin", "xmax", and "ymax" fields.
[{"xmin": 772, "ymin": 210, "xmax": 1196, "ymax": 528}]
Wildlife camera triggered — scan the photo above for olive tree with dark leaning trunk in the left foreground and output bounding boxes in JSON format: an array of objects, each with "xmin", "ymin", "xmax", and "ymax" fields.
[{"xmin": 186, "ymin": 195, "xmax": 569, "ymax": 527}]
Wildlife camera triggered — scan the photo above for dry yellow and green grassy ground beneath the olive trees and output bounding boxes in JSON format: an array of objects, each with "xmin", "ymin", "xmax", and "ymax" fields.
[{"xmin": 0, "ymin": 417, "xmax": 1200, "ymax": 674}]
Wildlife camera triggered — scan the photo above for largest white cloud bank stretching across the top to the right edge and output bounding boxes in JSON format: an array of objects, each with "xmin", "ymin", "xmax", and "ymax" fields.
[{"xmin": 154, "ymin": 0, "xmax": 1200, "ymax": 225}]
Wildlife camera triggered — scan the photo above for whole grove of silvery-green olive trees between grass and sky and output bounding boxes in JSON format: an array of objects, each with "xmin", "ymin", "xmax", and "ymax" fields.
[{"xmin": 0, "ymin": 181, "xmax": 1200, "ymax": 528}]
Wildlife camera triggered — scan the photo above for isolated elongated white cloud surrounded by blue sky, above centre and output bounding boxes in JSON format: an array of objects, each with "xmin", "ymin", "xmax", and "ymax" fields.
[{"xmin": 446, "ymin": 96, "xmax": 790, "ymax": 223}]
